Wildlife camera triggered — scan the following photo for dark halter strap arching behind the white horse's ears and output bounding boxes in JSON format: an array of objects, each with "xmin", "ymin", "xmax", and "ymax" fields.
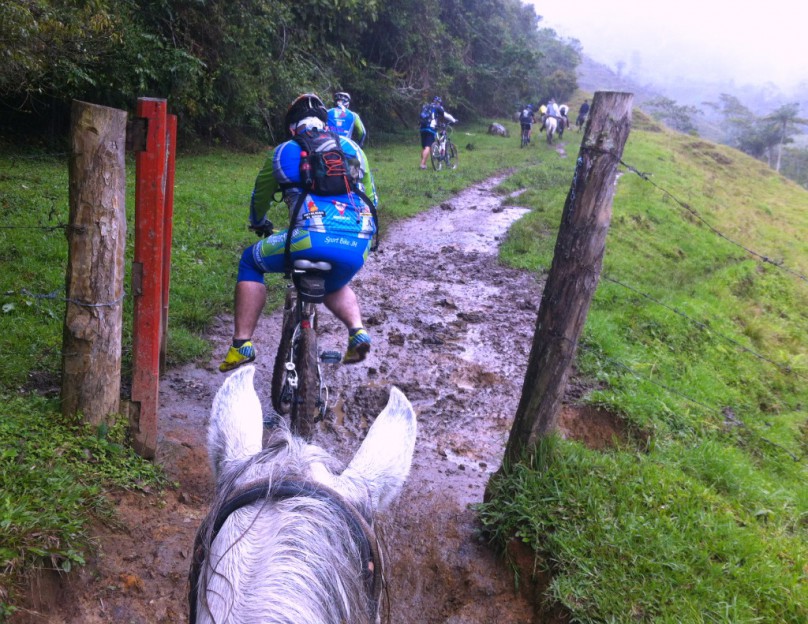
[{"xmin": 188, "ymin": 480, "xmax": 384, "ymax": 624}]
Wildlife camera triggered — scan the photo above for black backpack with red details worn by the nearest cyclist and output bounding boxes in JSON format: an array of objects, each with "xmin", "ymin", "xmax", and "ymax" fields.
[{"xmin": 281, "ymin": 130, "xmax": 379, "ymax": 275}]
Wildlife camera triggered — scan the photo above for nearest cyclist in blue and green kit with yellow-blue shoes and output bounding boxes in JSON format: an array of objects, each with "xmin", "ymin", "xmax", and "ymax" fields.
[{"xmin": 219, "ymin": 93, "xmax": 378, "ymax": 372}]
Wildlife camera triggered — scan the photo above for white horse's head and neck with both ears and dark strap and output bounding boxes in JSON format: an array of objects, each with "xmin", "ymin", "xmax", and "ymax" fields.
[{"xmin": 189, "ymin": 366, "xmax": 416, "ymax": 624}]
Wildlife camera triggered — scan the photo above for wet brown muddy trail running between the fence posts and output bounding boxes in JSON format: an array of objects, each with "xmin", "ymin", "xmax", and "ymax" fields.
[{"xmin": 13, "ymin": 174, "xmax": 610, "ymax": 624}]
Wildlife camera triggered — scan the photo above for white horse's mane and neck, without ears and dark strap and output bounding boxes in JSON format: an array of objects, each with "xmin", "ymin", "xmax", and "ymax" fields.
[{"xmin": 197, "ymin": 428, "xmax": 373, "ymax": 624}]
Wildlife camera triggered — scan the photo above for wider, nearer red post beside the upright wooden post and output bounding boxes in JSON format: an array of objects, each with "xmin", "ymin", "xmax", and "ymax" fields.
[{"xmin": 130, "ymin": 98, "xmax": 168, "ymax": 458}]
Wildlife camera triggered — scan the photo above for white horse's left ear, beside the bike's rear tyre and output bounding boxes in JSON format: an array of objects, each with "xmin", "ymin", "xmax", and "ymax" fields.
[{"xmin": 208, "ymin": 366, "xmax": 263, "ymax": 478}]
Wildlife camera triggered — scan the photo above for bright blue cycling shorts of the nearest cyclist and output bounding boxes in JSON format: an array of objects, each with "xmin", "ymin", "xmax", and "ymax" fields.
[{"xmin": 238, "ymin": 228, "xmax": 371, "ymax": 293}]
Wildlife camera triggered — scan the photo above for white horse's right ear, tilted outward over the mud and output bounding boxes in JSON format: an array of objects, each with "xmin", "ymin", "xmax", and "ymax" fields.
[{"xmin": 337, "ymin": 387, "xmax": 417, "ymax": 509}]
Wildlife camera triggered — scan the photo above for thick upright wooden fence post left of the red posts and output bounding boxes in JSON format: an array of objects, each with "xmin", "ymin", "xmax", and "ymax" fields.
[{"xmin": 61, "ymin": 101, "xmax": 126, "ymax": 425}]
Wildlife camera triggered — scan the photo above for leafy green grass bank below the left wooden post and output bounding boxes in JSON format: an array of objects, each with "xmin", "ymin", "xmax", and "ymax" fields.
[{"xmin": 0, "ymin": 394, "xmax": 165, "ymax": 620}]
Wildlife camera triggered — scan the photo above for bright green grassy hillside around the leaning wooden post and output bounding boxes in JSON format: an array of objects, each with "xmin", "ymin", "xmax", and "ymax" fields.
[{"xmin": 481, "ymin": 113, "xmax": 808, "ymax": 623}]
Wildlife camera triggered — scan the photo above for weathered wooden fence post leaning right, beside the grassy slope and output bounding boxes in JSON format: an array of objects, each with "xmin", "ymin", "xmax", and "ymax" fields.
[{"xmin": 505, "ymin": 92, "xmax": 634, "ymax": 463}]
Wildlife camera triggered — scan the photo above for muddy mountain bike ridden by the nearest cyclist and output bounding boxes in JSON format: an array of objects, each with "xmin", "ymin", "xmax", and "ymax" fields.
[{"xmin": 272, "ymin": 259, "xmax": 342, "ymax": 440}]
